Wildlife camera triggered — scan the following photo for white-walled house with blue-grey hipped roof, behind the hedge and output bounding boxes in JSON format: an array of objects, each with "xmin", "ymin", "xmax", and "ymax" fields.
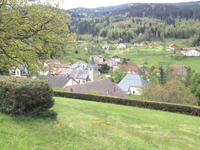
[{"xmin": 117, "ymin": 74, "xmax": 149, "ymax": 95}]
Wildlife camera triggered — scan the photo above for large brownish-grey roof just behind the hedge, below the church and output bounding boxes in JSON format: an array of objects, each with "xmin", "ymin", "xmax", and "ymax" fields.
[{"xmin": 68, "ymin": 78, "xmax": 127, "ymax": 97}]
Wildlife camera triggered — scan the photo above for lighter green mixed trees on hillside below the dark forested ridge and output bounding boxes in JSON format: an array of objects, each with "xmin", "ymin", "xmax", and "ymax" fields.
[{"xmin": 70, "ymin": 17, "xmax": 200, "ymax": 46}]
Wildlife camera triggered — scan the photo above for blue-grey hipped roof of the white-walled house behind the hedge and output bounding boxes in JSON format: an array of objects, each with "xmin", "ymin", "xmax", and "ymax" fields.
[{"xmin": 117, "ymin": 74, "xmax": 149, "ymax": 92}]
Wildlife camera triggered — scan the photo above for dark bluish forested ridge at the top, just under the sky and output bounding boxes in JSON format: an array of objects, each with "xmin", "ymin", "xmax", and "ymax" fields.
[{"xmin": 68, "ymin": 1, "xmax": 200, "ymax": 20}]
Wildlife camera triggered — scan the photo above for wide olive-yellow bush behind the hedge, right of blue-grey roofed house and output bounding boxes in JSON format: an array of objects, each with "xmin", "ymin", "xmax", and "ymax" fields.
[{"xmin": 142, "ymin": 80, "xmax": 198, "ymax": 105}]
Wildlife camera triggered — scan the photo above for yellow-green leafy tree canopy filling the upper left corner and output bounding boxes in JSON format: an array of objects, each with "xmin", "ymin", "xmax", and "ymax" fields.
[{"xmin": 0, "ymin": 0, "xmax": 76, "ymax": 73}]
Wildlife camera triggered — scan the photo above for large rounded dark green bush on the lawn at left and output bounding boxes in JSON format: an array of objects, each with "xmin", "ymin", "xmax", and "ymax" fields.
[{"xmin": 0, "ymin": 77, "xmax": 57, "ymax": 118}]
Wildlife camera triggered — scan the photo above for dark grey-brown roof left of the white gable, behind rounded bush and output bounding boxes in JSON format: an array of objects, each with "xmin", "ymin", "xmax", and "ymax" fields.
[{"xmin": 43, "ymin": 76, "xmax": 76, "ymax": 88}]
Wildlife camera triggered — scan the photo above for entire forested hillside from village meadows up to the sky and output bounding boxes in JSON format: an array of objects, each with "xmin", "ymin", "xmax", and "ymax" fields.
[{"xmin": 67, "ymin": 1, "xmax": 200, "ymax": 46}]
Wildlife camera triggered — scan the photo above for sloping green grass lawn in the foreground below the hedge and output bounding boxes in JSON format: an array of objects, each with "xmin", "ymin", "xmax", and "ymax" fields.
[{"xmin": 0, "ymin": 97, "xmax": 200, "ymax": 150}]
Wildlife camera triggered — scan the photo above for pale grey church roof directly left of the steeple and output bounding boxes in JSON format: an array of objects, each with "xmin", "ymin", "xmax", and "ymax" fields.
[{"xmin": 59, "ymin": 69, "xmax": 88, "ymax": 79}]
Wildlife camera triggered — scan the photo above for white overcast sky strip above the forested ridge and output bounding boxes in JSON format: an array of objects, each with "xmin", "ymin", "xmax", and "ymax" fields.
[{"xmin": 58, "ymin": 0, "xmax": 198, "ymax": 9}]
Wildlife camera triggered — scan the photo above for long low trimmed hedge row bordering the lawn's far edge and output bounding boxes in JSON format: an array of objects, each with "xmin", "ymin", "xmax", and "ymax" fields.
[{"xmin": 54, "ymin": 91, "xmax": 200, "ymax": 116}]
